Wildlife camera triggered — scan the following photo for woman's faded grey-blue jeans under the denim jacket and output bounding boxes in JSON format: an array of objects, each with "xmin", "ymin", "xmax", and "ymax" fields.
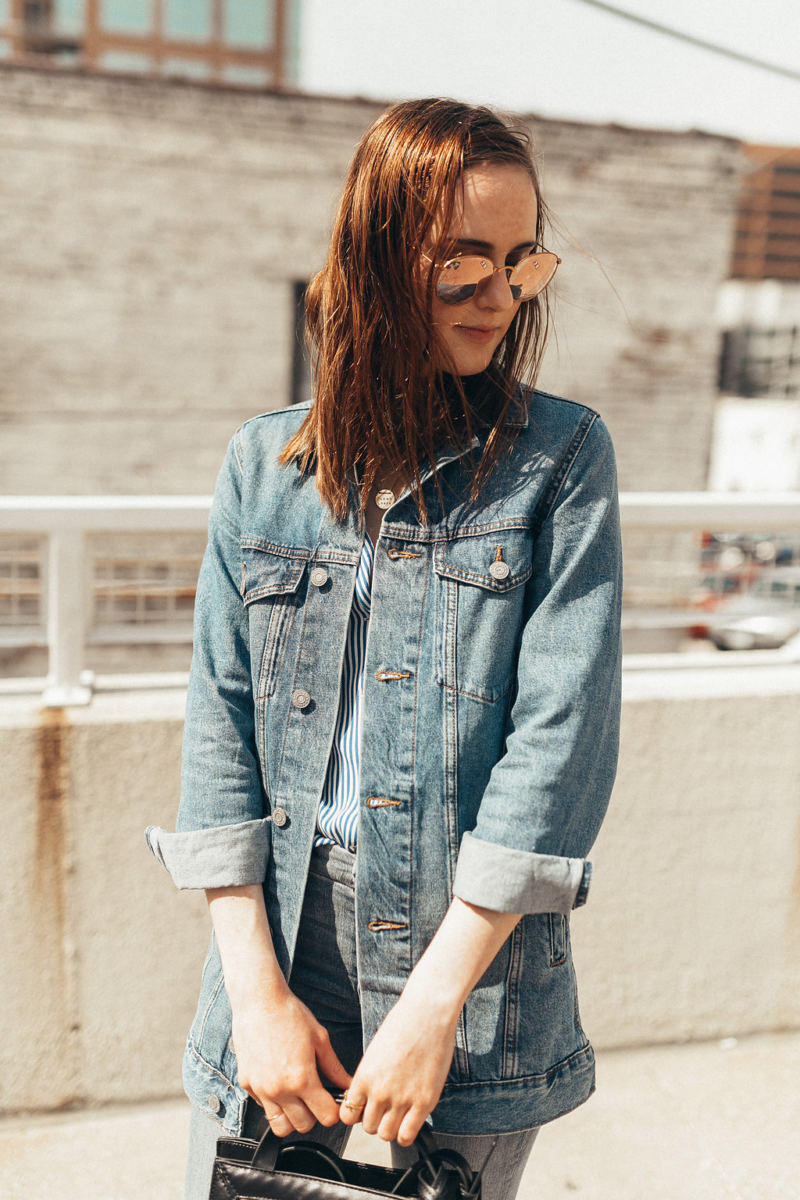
[{"xmin": 185, "ymin": 846, "xmax": 539, "ymax": 1200}]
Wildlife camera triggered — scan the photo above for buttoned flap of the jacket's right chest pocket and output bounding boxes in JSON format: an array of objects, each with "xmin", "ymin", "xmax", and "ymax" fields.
[{"xmin": 433, "ymin": 529, "xmax": 533, "ymax": 593}]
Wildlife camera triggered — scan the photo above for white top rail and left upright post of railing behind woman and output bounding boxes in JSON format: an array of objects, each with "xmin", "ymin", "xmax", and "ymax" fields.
[{"xmin": 0, "ymin": 492, "xmax": 800, "ymax": 706}]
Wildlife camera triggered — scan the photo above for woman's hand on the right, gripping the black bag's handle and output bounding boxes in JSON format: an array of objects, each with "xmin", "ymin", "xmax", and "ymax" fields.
[{"xmin": 339, "ymin": 992, "xmax": 461, "ymax": 1146}]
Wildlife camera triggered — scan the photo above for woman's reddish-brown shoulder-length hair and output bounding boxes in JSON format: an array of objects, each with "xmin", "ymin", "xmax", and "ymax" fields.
[{"xmin": 279, "ymin": 100, "xmax": 549, "ymax": 523}]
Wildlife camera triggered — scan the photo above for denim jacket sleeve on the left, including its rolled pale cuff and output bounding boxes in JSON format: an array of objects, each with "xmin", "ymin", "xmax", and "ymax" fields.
[{"xmin": 145, "ymin": 433, "xmax": 270, "ymax": 888}]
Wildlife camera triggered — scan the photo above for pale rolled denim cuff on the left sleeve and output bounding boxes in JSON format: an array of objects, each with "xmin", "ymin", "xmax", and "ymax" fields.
[{"xmin": 144, "ymin": 817, "xmax": 270, "ymax": 888}]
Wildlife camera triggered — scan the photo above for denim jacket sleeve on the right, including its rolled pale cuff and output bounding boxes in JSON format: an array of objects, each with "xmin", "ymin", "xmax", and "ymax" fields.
[{"xmin": 453, "ymin": 418, "xmax": 621, "ymax": 913}]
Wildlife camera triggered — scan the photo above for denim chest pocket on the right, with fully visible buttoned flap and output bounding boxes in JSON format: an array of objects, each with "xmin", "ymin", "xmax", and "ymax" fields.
[{"xmin": 433, "ymin": 528, "xmax": 533, "ymax": 703}]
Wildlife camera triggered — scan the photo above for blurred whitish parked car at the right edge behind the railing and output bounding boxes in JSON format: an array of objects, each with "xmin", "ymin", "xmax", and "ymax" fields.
[{"xmin": 708, "ymin": 566, "xmax": 800, "ymax": 650}]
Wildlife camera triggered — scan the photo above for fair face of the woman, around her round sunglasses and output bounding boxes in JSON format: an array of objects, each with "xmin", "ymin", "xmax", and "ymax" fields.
[{"xmin": 426, "ymin": 163, "xmax": 539, "ymax": 376}]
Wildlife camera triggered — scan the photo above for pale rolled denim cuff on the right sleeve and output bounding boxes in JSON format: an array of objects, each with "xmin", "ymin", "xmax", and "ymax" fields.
[{"xmin": 453, "ymin": 833, "xmax": 591, "ymax": 913}]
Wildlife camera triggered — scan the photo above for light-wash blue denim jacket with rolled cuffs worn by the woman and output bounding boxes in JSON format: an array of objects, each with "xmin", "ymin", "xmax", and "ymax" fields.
[{"xmin": 148, "ymin": 391, "xmax": 621, "ymax": 1133}]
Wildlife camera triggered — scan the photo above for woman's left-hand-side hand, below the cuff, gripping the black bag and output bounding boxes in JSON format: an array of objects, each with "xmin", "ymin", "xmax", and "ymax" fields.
[{"xmin": 233, "ymin": 988, "xmax": 350, "ymax": 1138}]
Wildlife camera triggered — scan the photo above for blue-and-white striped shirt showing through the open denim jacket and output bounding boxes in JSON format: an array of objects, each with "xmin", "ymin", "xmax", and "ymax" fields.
[{"xmin": 314, "ymin": 533, "xmax": 374, "ymax": 851}]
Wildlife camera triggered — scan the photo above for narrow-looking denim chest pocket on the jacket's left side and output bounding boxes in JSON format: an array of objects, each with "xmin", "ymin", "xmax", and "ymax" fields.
[{"xmin": 241, "ymin": 540, "xmax": 311, "ymax": 700}]
